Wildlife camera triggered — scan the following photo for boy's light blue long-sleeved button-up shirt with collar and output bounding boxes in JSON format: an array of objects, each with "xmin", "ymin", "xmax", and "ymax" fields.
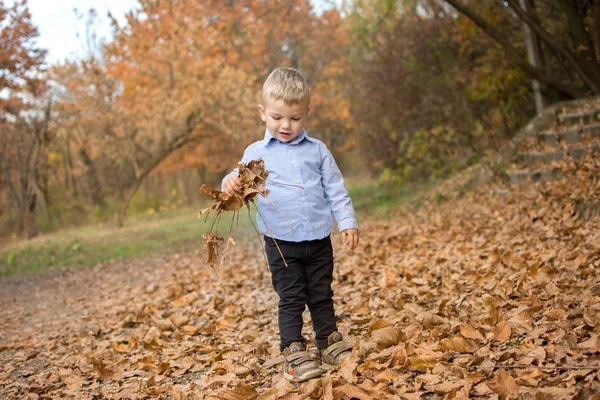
[{"xmin": 223, "ymin": 130, "xmax": 358, "ymax": 242}]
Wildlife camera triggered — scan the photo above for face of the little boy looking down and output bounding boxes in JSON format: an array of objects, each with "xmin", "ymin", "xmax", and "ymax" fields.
[{"xmin": 258, "ymin": 96, "xmax": 310, "ymax": 143}]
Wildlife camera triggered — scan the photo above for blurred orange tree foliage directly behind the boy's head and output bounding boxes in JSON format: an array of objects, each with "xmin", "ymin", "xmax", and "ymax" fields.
[{"xmin": 217, "ymin": 0, "xmax": 352, "ymax": 151}]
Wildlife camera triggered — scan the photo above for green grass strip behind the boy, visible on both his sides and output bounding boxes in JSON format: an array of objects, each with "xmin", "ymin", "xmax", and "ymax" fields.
[{"xmin": 0, "ymin": 178, "xmax": 430, "ymax": 277}]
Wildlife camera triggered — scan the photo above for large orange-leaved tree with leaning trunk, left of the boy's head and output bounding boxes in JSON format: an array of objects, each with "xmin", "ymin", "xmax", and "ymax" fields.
[{"xmin": 105, "ymin": 1, "xmax": 254, "ymax": 226}]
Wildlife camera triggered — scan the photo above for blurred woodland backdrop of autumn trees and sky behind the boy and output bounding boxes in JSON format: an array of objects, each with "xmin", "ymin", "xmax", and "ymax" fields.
[{"xmin": 0, "ymin": 0, "xmax": 600, "ymax": 240}]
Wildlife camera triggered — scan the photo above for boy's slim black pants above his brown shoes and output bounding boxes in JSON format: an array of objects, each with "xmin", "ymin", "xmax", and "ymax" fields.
[{"xmin": 265, "ymin": 236, "xmax": 336, "ymax": 351}]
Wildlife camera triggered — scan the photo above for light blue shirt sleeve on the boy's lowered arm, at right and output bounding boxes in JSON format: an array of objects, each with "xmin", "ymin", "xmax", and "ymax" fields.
[{"xmin": 321, "ymin": 144, "xmax": 358, "ymax": 232}]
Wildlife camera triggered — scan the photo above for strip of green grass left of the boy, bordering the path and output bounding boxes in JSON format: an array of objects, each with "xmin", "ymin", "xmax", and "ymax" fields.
[{"xmin": 0, "ymin": 209, "xmax": 256, "ymax": 277}]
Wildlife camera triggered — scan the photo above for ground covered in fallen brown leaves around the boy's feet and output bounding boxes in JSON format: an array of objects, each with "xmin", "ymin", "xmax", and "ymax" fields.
[{"xmin": 0, "ymin": 155, "xmax": 600, "ymax": 400}]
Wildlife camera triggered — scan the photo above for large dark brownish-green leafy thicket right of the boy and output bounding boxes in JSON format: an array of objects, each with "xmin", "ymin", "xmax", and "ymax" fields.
[{"xmin": 347, "ymin": 0, "xmax": 530, "ymax": 181}]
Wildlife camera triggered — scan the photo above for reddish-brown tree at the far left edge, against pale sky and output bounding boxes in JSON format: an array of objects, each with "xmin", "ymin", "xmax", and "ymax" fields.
[{"xmin": 0, "ymin": 0, "xmax": 51, "ymax": 238}]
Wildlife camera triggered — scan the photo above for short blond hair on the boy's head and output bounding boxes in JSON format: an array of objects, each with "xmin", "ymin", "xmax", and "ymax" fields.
[{"xmin": 262, "ymin": 67, "xmax": 310, "ymax": 106}]
